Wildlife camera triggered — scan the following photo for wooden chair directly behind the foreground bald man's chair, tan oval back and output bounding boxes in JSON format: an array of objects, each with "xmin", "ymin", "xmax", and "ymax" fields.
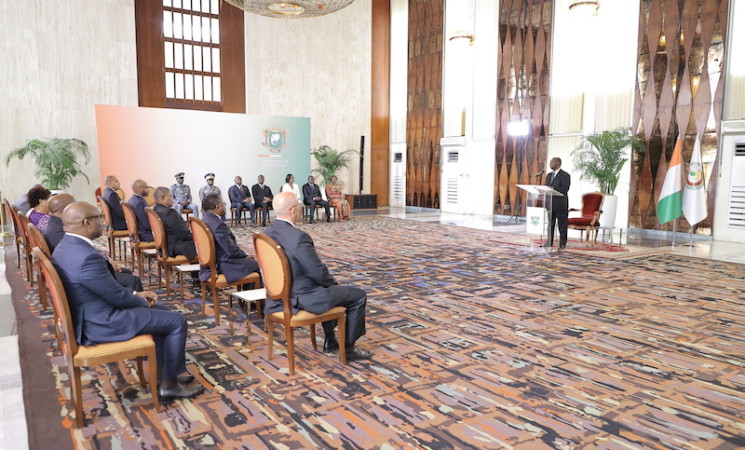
[{"xmin": 189, "ymin": 217, "xmax": 261, "ymax": 326}]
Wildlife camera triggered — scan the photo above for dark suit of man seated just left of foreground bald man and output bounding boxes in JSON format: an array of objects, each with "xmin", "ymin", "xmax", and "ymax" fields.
[{"xmin": 199, "ymin": 212, "xmax": 259, "ymax": 283}]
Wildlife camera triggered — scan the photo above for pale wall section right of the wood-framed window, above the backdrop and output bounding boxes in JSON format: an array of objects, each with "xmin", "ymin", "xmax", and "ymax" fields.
[{"xmin": 245, "ymin": 0, "xmax": 372, "ymax": 193}]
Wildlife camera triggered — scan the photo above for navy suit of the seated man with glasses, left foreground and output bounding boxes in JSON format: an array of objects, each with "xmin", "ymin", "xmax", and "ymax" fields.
[{"xmin": 52, "ymin": 234, "xmax": 187, "ymax": 379}]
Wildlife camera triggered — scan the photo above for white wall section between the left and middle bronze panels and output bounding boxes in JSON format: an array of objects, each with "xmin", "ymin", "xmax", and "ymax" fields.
[{"xmin": 440, "ymin": 0, "xmax": 499, "ymax": 215}]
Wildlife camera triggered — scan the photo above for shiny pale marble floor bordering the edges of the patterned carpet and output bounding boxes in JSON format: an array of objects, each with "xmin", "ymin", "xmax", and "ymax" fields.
[{"xmin": 0, "ymin": 207, "xmax": 745, "ymax": 449}]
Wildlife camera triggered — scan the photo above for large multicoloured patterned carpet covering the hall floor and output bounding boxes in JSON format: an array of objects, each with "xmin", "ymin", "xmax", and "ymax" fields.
[{"xmin": 17, "ymin": 217, "xmax": 745, "ymax": 449}]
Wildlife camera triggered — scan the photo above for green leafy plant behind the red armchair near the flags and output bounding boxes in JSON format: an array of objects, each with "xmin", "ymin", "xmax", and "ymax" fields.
[{"xmin": 572, "ymin": 128, "xmax": 643, "ymax": 195}]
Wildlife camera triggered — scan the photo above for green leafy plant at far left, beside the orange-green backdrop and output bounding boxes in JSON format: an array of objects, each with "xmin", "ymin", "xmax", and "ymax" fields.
[{"xmin": 5, "ymin": 138, "xmax": 91, "ymax": 190}]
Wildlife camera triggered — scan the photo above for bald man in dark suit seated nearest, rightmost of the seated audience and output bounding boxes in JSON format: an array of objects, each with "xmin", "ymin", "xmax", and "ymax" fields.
[{"xmin": 264, "ymin": 192, "xmax": 372, "ymax": 361}]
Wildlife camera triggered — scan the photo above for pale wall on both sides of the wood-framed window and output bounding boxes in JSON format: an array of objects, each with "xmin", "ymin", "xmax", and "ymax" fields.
[{"xmin": 0, "ymin": 0, "xmax": 371, "ymax": 206}]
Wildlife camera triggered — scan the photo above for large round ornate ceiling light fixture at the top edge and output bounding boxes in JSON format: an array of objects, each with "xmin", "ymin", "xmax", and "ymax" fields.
[{"xmin": 225, "ymin": 0, "xmax": 354, "ymax": 18}]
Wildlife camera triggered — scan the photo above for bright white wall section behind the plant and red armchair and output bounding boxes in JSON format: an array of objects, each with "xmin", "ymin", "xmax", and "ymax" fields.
[{"xmin": 547, "ymin": 0, "xmax": 639, "ymax": 227}]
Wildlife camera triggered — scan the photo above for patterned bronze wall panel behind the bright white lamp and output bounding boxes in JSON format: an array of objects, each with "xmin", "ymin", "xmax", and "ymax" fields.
[{"xmin": 494, "ymin": 0, "xmax": 553, "ymax": 214}]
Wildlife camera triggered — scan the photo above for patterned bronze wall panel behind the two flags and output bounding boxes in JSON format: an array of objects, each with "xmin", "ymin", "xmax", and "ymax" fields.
[{"xmin": 629, "ymin": 0, "xmax": 729, "ymax": 234}]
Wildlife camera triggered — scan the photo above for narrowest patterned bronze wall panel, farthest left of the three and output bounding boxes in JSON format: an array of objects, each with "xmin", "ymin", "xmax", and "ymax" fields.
[{"xmin": 406, "ymin": 0, "xmax": 444, "ymax": 208}]
